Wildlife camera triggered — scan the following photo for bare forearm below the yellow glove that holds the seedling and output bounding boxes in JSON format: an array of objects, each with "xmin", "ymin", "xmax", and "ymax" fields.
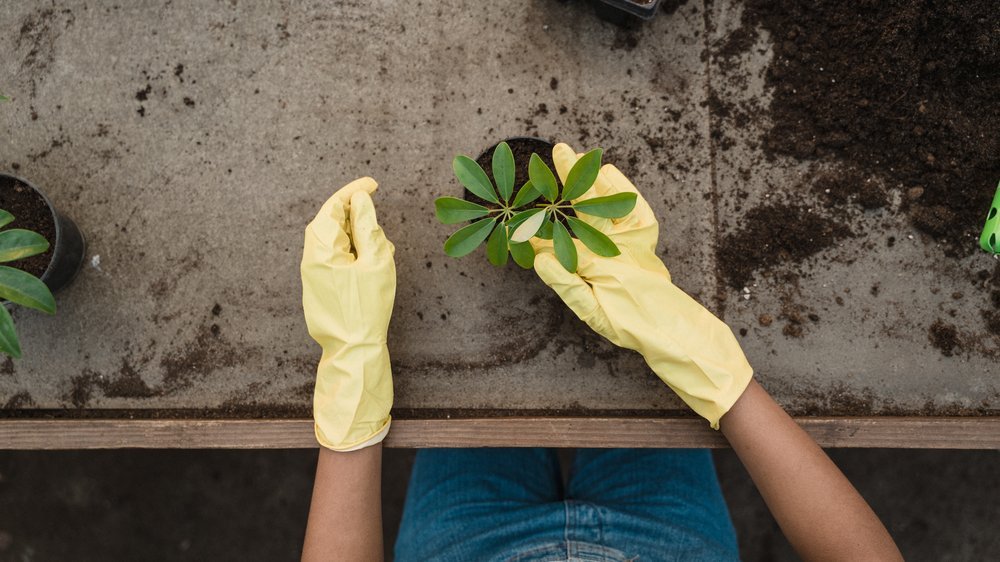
[{"xmin": 720, "ymin": 381, "xmax": 902, "ymax": 560}]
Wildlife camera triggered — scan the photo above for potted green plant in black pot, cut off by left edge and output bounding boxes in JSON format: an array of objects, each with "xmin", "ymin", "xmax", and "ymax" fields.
[{"xmin": 0, "ymin": 95, "xmax": 85, "ymax": 358}]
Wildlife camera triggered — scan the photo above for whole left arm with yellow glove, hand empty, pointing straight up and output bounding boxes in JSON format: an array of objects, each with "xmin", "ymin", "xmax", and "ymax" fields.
[{"xmin": 301, "ymin": 178, "xmax": 396, "ymax": 561}]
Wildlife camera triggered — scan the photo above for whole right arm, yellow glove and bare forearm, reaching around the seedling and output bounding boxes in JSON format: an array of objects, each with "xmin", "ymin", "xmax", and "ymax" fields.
[{"xmin": 532, "ymin": 144, "xmax": 899, "ymax": 560}]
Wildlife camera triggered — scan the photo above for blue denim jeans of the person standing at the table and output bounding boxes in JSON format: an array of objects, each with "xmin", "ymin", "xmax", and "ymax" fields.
[{"xmin": 396, "ymin": 449, "xmax": 739, "ymax": 562}]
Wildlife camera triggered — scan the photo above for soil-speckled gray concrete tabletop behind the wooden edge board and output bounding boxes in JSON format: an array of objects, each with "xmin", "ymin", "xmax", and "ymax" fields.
[{"xmin": 0, "ymin": 0, "xmax": 1000, "ymax": 414}]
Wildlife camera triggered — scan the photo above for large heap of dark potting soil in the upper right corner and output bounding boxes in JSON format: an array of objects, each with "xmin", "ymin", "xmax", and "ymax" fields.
[{"xmin": 743, "ymin": 0, "xmax": 1000, "ymax": 256}]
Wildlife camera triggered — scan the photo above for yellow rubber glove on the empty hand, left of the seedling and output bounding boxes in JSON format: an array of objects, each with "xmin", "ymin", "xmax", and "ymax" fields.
[{"xmin": 302, "ymin": 178, "xmax": 396, "ymax": 451}]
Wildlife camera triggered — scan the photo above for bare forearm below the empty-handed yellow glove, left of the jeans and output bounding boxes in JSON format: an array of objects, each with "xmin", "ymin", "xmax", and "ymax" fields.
[{"xmin": 302, "ymin": 444, "xmax": 383, "ymax": 562}]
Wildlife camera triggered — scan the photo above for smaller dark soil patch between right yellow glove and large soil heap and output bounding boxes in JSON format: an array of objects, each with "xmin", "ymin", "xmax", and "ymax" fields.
[{"xmin": 718, "ymin": 203, "xmax": 852, "ymax": 289}]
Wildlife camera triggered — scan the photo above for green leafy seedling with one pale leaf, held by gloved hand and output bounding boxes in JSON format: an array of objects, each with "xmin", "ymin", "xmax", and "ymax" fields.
[{"xmin": 434, "ymin": 142, "xmax": 636, "ymax": 272}]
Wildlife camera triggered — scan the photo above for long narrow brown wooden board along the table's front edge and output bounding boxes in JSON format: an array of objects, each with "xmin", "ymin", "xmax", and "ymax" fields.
[{"xmin": 0, "ymin": 417, "xmax": 1000, "ymax": 450}]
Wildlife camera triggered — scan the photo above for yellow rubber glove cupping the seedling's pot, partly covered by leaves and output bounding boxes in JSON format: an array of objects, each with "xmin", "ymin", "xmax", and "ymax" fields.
[{"xmin": 531, "ymin": 144, "xmax": 753, "ymax": 429}]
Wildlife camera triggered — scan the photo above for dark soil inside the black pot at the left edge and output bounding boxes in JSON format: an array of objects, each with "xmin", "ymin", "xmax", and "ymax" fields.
[{"xmin": 0, "ymin": 176, "xmax": 56, "ymax": 277}]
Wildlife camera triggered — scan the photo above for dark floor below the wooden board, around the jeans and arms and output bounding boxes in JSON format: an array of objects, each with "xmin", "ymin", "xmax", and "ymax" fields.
[{"xmin": 0, "ymin": 449, "xmax": 1000, "ymax": 562}]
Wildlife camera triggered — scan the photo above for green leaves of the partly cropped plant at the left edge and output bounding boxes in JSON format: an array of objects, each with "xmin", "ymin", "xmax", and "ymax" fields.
[{"xmin": 0, "ymin": 210, "xmax": 56, "ymax": 359}]
